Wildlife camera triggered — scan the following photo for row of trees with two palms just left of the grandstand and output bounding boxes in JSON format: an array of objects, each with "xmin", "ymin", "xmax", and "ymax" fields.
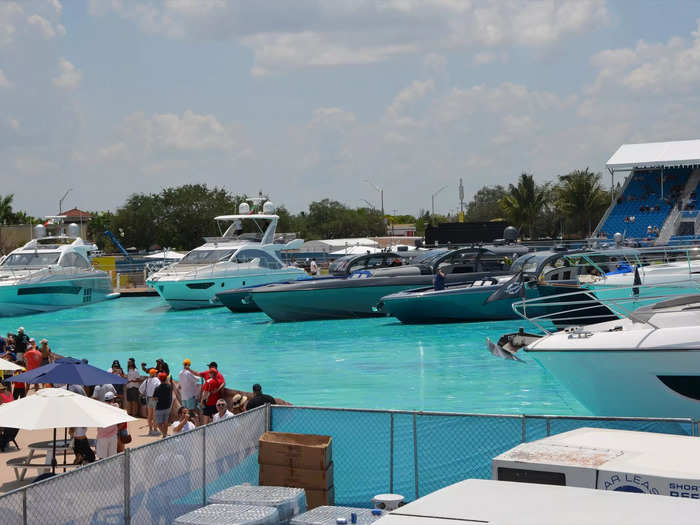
[{"xmin": 465, "ymin": 168, "xmax": 610, "ymax": 239}]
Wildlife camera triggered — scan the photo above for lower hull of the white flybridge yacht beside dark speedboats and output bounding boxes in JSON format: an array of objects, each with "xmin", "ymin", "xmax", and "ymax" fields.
[{"xmin": 147, "ymin": 269, "xmax": 305, "ymax": 310}]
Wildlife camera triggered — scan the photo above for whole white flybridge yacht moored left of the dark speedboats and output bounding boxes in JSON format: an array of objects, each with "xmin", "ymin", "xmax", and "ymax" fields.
[{"xmin": 146, "ymin": 201, "xmax": 306, "ymax": 310}]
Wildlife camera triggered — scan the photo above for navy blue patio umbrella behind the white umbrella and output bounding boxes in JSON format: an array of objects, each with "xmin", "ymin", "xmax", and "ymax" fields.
[{"xmin": 8, "ymin": 357, "xmax": 127, "ymax": 385}]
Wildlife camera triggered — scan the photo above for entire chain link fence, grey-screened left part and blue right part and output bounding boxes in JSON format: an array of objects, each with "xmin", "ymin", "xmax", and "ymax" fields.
[{"xmin": 0, "ymin": 406, "xmax": 697, "ymax": 525}]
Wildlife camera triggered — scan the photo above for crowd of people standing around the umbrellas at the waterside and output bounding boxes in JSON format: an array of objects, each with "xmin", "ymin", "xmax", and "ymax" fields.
[{"xmin": 0, "ymin": 327, "xmax": 275, "ymax": 464}]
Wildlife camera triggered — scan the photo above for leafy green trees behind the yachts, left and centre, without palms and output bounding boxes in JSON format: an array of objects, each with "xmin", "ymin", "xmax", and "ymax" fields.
[{"xmin": 88, "ymin": 184, "xmax": 386, "ymax": 251}]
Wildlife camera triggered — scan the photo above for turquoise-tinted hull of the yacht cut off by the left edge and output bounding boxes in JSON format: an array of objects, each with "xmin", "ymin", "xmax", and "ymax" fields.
[{"xmin": 0, "ymin": 274, "xmax": 112, "ymax": 317}]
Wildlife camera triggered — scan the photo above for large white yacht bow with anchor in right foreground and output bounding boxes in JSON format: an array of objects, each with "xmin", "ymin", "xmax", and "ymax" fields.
[{"xmin": 488, "ymin": 294, "xmax": 700, "ymax": 418}]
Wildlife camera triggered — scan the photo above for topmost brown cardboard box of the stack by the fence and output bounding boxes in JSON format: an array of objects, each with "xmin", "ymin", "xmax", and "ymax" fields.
[{"xmin": 258, "ymin": 432, "xmax": 332, "ymax": 470}]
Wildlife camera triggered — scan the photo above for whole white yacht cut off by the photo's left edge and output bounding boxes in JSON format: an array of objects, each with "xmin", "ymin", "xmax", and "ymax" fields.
[{"xmin": 0, "ymin": 216, "xmax": 119, "ymax": 317}]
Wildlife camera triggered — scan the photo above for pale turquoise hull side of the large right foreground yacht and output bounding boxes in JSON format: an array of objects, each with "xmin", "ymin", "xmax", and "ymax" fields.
[{"xmin": 526, "ymin": 348, "xmax": 700, "ymax": 418}]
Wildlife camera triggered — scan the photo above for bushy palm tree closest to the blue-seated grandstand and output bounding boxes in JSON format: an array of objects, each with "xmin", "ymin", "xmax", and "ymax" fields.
[{"xmin": 555, "ymin": 168, "xmax": 610, "ymax": 236}]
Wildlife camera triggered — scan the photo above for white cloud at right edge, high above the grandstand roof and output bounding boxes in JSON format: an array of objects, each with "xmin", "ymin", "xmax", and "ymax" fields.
[{"xmin": 588, "ymin": 19, "xmax": 700, "ymax": 94}]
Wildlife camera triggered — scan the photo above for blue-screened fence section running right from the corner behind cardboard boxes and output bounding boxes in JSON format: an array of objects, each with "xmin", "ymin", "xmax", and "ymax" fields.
[{"xmin": 271, "ymin": 406, "xmax": 697, "ymax": 507}]
